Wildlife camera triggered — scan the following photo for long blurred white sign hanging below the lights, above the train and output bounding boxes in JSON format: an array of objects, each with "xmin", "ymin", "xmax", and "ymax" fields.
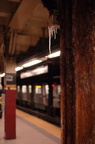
[{"xmin": 20, "ymin": 66, "xmax": 48, "ymax": 79}]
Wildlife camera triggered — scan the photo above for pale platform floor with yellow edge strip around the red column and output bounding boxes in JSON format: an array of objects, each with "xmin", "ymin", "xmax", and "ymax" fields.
[{"xmin": 0, "ymin": 110, "xmax": 60, "ymax": 144}]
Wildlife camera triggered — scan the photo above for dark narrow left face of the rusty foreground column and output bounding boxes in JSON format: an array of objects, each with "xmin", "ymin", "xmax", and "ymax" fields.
[{"xmin": 60, "ymin": 0, "xmax": 76, "ymax": 144}]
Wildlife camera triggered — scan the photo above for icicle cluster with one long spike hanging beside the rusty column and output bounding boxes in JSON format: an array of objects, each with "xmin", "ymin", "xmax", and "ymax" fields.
[{"xmin": 48, "ymin": 25, "xmax": 57, "ymax": 54}]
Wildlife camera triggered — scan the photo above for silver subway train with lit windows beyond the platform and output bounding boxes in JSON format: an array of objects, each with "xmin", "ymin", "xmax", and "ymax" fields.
[{"xmin": 16, "ymin": 84, "xmax": 60, "ymax": 117}]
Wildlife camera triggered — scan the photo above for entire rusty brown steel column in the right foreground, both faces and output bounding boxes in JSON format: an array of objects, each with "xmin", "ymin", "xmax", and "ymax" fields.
[{"xmin": 42, "ymin": 0, "xmax": 95, "ymax": 144}]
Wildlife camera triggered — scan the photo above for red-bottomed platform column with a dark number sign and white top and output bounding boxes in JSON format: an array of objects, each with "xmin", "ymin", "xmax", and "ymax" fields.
[{"xmin": 4, "ymin": 60, "xmax": 16, "ymax": 139}]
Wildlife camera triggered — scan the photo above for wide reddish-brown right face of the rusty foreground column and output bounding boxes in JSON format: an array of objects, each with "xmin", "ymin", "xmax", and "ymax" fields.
[{"xmin": 73, "ymin": 0, "xmax": 95, "ymax": 144}]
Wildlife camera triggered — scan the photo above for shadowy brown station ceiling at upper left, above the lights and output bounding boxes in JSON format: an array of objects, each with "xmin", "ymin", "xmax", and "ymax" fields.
[{"xmin": 0, "ymin": 0, "xmax": 53, "ymax": 72}]
